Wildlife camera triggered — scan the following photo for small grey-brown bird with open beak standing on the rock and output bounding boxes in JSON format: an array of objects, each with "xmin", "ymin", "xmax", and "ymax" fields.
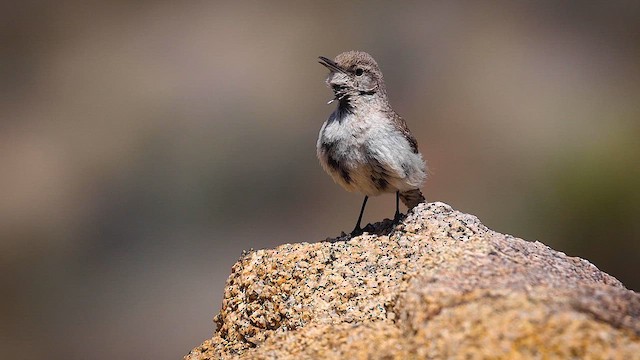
[{"xmin": 317, "ymin": 51, "xmax": 427, "ymax": 236}]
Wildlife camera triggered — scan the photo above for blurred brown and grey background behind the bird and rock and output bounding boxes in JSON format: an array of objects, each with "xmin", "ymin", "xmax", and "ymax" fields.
[{"xmin": 0, "ymin": 0, "xmax": 640, "ymax": 360}]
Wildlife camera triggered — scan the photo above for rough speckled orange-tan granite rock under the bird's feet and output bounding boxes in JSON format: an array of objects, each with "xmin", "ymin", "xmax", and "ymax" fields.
[{"xmin": 185, "ymin": 203, "xmax": 640, "ymax": 360}]
